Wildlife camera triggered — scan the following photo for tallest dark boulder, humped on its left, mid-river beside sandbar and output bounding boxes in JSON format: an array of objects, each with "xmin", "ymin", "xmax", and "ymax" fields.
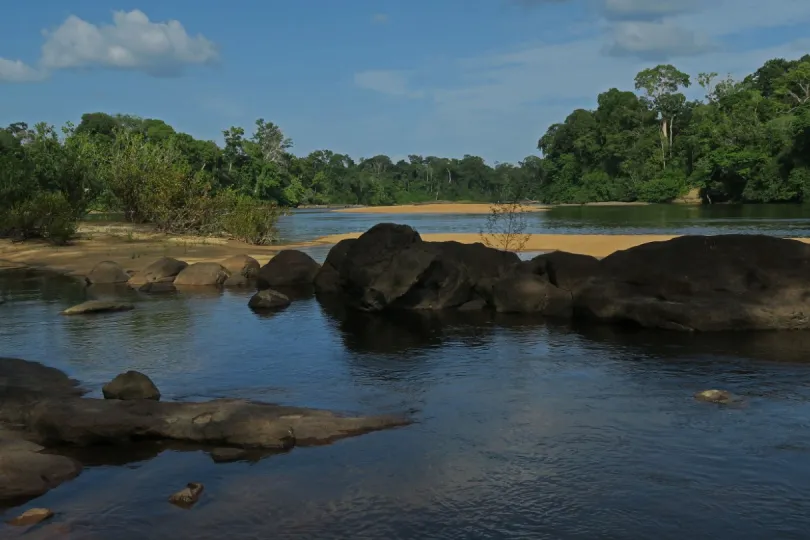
[{"xmin": 340, "ymin": 223, "xmax": 520, "ymax": 311}]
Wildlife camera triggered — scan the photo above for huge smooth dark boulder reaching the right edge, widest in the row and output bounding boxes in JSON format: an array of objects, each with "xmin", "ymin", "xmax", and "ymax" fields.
[{"xmin": 574, "ymin": 235, "xmax": 810, "ymax": 331}]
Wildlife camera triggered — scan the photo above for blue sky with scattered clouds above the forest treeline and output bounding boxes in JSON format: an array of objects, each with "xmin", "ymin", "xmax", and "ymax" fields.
[{"xmin": 0, "ymin": 0, "xmax": 810, "ymax": 163}]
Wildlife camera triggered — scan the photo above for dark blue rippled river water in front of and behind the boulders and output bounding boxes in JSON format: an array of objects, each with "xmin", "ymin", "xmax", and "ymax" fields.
[{"xmin": 0, "ymin": 207, "xmax": 810, "ymax": 540}]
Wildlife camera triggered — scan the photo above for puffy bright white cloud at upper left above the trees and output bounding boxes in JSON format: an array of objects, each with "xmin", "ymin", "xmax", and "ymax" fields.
[{"xmin": 0, "ymin": 9, "xmax": 218, "ymax": 82}]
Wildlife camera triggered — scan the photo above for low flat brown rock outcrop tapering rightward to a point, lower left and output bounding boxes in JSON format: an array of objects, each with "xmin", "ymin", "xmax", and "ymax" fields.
[{"xmin": 0, "ymin": 358, "xmax": 409, "ymax": 499}]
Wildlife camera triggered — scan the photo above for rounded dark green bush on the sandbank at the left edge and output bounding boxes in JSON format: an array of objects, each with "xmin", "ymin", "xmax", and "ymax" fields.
[{"xmin": 0, "ymin": 192, "xmax": 78, "ymax": 245}]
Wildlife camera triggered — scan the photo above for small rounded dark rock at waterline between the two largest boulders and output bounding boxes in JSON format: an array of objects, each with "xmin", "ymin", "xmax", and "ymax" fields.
[{"xmin": 492, "ymin": 274, "xmax": 573, "ymax": 318}]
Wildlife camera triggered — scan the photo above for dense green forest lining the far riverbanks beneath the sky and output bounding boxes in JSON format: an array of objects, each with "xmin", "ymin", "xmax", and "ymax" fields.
[{"xmin": 0, "ymin": 55, "xmax": 810, "ymax": 243}]
